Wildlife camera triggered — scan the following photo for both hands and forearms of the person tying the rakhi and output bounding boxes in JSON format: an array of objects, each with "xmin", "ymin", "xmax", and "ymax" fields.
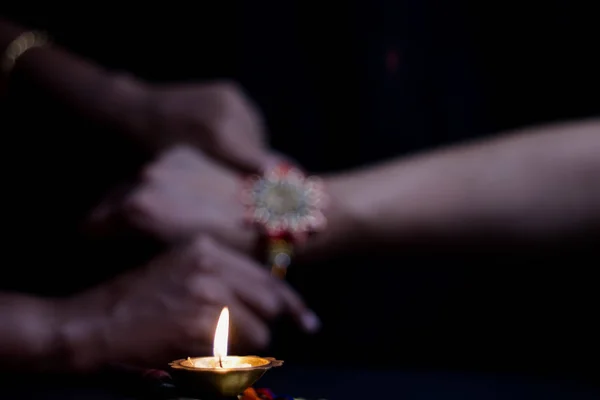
[{"xmin": 0, "ymin": 14, "xmax": 310, "ymax": 371}]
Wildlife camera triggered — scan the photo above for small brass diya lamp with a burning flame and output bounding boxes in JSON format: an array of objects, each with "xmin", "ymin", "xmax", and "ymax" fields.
[{"xmin": 169, "ymin": 307, "xmax": 283, "ymax": 399}]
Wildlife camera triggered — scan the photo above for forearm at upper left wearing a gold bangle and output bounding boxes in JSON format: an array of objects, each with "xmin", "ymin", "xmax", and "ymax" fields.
[{"xmin": 0, "ymin": 18, "xmax": 142, "ymax": 133}]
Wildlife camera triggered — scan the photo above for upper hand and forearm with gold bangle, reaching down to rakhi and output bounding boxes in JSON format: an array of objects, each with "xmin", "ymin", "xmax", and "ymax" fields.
[{"xmin": 0, "ymin": 17, "xmax": 268, "ymax": 172}]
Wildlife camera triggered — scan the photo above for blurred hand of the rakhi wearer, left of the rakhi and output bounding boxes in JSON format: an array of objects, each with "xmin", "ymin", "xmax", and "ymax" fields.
[{"xmin": 91, "ymin": 145, "xmax": 259, "ymax": 253}]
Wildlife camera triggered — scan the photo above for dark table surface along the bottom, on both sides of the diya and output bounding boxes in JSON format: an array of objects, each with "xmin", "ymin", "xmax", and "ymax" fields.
[{"xmin": 0, "ymin": 365, "xmax": 600, "ymax": 400}]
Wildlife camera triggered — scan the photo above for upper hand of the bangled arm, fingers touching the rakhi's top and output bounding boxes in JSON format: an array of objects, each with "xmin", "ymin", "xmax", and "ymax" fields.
[{"xmin": 128, "ymin": 82, "xmax": 267, "ymax": 172}]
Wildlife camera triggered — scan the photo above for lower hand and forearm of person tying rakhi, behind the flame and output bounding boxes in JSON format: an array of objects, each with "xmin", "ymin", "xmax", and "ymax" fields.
[{"xmin": 0, "ymin": 237, "xmax": 319, "ymax": 372}]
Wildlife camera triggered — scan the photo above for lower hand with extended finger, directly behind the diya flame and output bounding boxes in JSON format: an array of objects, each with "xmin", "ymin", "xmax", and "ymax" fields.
[{"xmin": 63, "ymin": 238, "xmax": 319, "ymax": 369}]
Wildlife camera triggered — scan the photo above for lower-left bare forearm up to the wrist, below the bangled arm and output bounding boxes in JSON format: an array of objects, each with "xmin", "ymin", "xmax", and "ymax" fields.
[{"xmin": 0, "ymin": 274, "xmax": 131, "ymax": 372}]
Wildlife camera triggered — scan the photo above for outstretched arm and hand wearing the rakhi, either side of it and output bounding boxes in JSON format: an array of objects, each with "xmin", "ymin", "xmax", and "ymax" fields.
[{"xmin": 90, "ymin": 119, "xmax": 600, "ymax": 259}]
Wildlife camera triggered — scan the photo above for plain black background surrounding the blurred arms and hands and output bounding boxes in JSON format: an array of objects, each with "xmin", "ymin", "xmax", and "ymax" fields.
[{"xmin": 0, "ymin": 0, "xmax": 600, "ymax": 388}]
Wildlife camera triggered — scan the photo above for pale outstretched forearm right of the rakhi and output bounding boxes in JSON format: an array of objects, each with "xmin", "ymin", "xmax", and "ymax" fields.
[{"xmin": 307, "ymin": 120, "xmax": 600, "ymax": 252}]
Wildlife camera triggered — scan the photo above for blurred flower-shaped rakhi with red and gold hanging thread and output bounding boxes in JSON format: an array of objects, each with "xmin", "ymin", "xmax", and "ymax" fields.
[{"xmin": 242, "ymin": 162, "xmax": 327, "ymax": 278}]
